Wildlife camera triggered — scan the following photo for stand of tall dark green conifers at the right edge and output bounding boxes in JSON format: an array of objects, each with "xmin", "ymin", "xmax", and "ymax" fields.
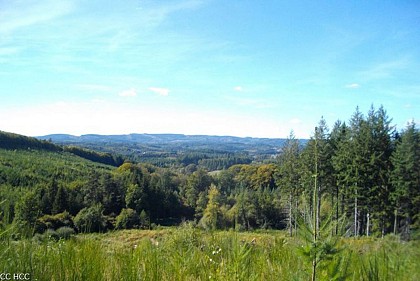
[{"xmin": 279, "ymin": 106, "xmax": 420, "ymax": 236}]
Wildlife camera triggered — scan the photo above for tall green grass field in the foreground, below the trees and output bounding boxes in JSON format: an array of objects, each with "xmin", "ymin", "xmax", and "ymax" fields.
[{"xmin": 0, "ymin": 224, "xmax": 420, "ymax": 281}]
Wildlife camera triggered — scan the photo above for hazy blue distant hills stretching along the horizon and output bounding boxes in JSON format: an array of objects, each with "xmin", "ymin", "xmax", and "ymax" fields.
[{"xmin": 38, "ymin": 134, "xmax": 306, "ymax": 162}]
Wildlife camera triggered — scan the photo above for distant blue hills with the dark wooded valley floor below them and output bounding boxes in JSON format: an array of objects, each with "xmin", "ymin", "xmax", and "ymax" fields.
[{"xmin": 38, "ymin": 134, "xmax": 288, "ymax": 168}]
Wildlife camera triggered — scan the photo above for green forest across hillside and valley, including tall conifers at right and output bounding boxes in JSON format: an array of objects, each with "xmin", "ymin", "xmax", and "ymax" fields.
[{"xmin": 0, "ymin": 107, "xmax": 420, "ymax": 239}]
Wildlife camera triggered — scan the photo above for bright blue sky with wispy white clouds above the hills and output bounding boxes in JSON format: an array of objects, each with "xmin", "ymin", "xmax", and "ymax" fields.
[{"xmin": 0, "ymin": 0, "xmax": 420, "ymax": 138}]
